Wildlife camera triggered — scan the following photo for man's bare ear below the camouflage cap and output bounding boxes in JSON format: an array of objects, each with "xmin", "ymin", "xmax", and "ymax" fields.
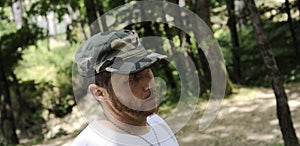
[{"xmin": 88, "ymin": 84, "xmax": 109, "ymax": 101}]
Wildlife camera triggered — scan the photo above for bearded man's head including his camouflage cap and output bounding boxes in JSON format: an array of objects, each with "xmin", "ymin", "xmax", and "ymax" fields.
[{"xmin": 75, "ymin": 30, "xmax": 166, "ymax": 117}]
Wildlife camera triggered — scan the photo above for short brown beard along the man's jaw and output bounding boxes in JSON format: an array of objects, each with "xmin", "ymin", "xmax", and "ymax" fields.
[{"xmin": 109, "ymin": 91, "xmax": 158, "ymax": 117}]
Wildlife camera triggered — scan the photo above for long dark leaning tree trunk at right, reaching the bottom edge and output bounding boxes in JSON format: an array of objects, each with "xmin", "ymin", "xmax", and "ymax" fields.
[{"xmin": 244, "ymin": 0, "xmax": 299, "ymax": 146}]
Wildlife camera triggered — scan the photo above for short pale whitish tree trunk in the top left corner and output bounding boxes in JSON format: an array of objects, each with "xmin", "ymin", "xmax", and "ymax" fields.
[{"xmin": 12, "ymin": 0, "xmax": 23, "ymax": 28}]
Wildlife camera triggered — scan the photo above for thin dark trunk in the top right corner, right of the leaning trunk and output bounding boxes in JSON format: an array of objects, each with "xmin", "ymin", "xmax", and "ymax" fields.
[{"xmin": 285, "ymin": 0, "xmax": 300, "ymax": 57}]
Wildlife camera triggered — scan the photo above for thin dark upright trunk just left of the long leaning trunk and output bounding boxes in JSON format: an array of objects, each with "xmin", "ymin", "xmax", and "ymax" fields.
[{"xmin": 226, "ymin": 0, "xmax": 241, "ymax": 82}]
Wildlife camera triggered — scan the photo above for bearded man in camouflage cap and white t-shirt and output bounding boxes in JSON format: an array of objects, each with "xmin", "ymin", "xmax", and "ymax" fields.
[{"xmin": 72, "ymin": 30, "xmax": 178, "ymax": 146}]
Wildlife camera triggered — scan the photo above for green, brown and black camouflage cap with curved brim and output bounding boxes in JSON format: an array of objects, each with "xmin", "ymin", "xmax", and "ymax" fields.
[{"xmin": 75, "ymin": 30, "xmax": 167, "ymax": 77}]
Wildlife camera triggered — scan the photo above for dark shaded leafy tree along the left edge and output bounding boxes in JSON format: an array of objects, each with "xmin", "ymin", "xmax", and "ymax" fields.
[{"xmin": 0, "ymin": 1, "xmax": 42, "ymax": 139}]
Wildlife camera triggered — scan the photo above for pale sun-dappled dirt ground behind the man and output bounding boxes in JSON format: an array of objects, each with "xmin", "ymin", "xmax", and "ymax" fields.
[{"xmin": 27, "ymin": 85, "xmax": 300, "ymax": 146}]
